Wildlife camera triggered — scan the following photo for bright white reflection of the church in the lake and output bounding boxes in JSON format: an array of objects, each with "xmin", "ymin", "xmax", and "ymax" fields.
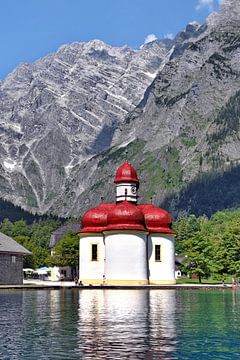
[{"xmin": 78, "ymin": 290, "xmax": 176, "ymax": 359}]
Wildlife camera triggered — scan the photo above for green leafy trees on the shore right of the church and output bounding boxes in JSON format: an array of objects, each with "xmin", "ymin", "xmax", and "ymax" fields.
[{"xmin": 174, "ymin": 209, "xmax": 240, "ymax": 282}]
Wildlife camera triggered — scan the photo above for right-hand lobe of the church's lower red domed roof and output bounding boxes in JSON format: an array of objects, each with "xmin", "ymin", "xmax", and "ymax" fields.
[{"xmin": 138, "ymin": 204, "xmax": 174, "ymax": 234}]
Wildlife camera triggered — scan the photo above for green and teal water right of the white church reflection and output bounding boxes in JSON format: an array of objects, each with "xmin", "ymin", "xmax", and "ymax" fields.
[{"xmin": 173, "ymin": 290, "xmax": 240, "ymax": 360}]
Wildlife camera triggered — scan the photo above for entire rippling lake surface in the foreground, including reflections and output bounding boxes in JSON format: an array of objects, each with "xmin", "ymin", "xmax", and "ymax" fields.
[{"xmin": 0, "ymin": 289, "xmax": 240, "ymax": 360}]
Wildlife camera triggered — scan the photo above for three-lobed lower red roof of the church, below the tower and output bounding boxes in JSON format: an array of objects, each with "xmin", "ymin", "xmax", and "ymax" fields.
[{"xmin": 81, "ymin": 200, "xmax": 173, "ymax": 234}]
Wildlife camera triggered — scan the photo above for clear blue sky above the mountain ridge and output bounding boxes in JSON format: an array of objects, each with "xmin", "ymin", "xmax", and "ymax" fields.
[{"xmin": 0, "ymin": 0, "xmax": 219, "ymax": 79}]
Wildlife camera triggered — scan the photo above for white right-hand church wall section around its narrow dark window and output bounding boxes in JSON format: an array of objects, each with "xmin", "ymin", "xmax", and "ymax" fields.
[{"xmin": 148, "ymin": 234, "xmax": 175, "ymax": 282}]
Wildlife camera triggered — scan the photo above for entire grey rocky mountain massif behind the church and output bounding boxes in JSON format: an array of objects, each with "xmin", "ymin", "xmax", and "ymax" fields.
[{"xmin": 0, "ymin": 0, "xmax": 240, "ymax": 216}]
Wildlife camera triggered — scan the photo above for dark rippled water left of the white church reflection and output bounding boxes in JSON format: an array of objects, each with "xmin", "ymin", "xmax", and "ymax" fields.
[{"xmin": 0, "ymin": 290, "xmax": 79, "ymax": 360}]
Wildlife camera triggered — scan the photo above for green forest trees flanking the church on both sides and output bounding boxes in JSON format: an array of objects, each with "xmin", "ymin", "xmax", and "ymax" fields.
[{"xmin": 0, "ymin": 205, "xmax": 240, "ymax": 282}]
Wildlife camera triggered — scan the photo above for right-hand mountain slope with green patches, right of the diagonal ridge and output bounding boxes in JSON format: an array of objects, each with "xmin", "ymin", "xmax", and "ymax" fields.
[{"xmin": 68, "ymin": 0, "xmax": 240, "ymax": 215}]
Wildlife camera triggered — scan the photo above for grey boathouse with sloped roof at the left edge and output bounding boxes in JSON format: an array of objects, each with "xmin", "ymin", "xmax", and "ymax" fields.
[{"xmin": 0, "ymin": 233, "xmax": 32, "ymax": 285}]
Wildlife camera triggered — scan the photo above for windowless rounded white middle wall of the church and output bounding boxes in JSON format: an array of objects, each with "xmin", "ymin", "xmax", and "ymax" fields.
[{"xmin": 105, "ymin": 230, "xmax": 147, "ymax": 281}]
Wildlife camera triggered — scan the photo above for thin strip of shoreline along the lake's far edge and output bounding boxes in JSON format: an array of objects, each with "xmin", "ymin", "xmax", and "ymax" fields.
[{"xmin": 0, "ymin": 280, "xmax": 236, "ymax": 291}]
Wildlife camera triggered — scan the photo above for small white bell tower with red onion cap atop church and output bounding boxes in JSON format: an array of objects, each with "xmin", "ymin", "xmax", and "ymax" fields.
[{"xmin": 114, "ymin": 160, "xmax": 139, "ymax": 203}]
